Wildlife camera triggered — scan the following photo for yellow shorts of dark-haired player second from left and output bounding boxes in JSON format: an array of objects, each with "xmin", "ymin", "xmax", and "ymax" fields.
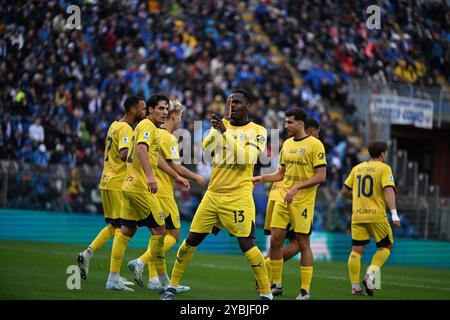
[{"xmin": 120, "ymin": 191, "xmax": 165, "ymax": 228}]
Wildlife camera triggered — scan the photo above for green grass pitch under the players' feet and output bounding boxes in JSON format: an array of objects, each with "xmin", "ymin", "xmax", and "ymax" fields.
[{"xmin": 0, "ymin": 241, "xmax": 450, "ymax": 300}]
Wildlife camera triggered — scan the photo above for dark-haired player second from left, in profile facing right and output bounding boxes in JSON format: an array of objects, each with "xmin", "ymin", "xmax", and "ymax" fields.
[{"xmin": 106, "ymin": 95, "xmax": 189, "ymax": 291}]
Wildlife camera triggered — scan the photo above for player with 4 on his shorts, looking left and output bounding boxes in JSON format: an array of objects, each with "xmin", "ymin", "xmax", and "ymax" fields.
[{"xmin": 253, "ymin": 108, "xmax": 326, "ymax": 300}]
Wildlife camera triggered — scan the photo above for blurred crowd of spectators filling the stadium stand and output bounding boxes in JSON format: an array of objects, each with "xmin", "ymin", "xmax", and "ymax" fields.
[{"xmin": 0, "ymin": 0, "xmax": 442, "ymax": 238}]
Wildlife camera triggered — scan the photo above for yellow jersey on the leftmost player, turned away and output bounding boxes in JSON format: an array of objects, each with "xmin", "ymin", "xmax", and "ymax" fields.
[{"xmin": 100, "ymin": 121, "xmax": 133, "ymax": 191}]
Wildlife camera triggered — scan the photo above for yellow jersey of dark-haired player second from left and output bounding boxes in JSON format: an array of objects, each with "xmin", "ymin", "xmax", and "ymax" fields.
[{"xmin": 122, "ymin": 119, "xmax": 159, "ymax": 193}]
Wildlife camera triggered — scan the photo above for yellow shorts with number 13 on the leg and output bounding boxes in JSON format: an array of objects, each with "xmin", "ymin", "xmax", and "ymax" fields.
[{"xmin": 190, "ymin": 192, "xmax": 255, "ymax": 238}]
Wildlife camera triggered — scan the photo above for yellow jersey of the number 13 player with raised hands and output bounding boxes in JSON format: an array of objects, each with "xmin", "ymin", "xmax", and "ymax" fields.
[{"xmin": 203, "ymin": 120, "xmax": 267, "ymax": 195}]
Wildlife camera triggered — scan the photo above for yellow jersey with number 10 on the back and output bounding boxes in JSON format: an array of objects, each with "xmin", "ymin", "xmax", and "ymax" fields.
[{"xmin": 344, "ymin": 161, "xmax": 395, "ymax": 223}]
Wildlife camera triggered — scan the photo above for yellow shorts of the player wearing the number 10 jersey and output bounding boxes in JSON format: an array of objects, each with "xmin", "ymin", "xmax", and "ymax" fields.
[{"xmin": 352, "ymin": 220, "xmax": 394, "ymax": 248}]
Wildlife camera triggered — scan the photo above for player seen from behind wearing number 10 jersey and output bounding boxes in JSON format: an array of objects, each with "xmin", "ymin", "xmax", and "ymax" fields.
[{"xmin": 342, "ymin": 141, "xmax": 400, "ymax": 296}]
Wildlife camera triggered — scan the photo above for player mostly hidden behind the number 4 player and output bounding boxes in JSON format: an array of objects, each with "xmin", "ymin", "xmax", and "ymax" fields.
[{"xmin": 264, "ymin": 119, "xmax": 320, "ymax": 286}]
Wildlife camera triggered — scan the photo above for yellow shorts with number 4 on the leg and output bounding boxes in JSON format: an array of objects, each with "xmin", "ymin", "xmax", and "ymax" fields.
[{"xmin": 270, "ymin": 201, "xmax": 314, "ymax": 235}]
